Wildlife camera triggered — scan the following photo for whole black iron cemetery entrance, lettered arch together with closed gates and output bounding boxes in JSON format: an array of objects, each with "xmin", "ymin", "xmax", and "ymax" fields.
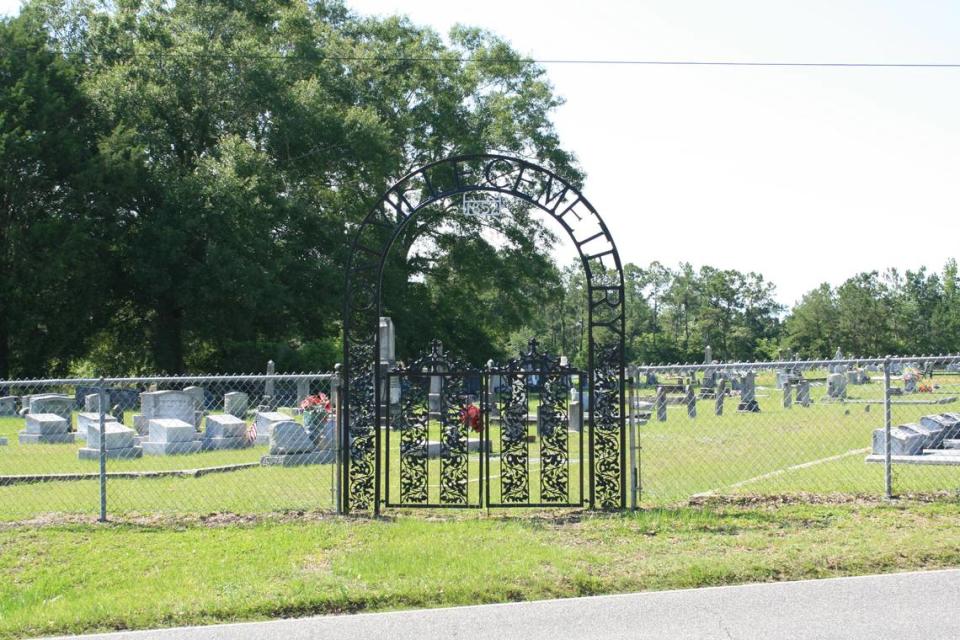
[{"xmin": 339, "ymin": 155, "xmax": 626, "ymax": 512}]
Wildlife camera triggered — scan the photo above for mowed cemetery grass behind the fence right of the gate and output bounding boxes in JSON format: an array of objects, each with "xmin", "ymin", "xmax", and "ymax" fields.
[{"xmin": 639, "ymin": 377, "xmax": 960, "ymax": 504}]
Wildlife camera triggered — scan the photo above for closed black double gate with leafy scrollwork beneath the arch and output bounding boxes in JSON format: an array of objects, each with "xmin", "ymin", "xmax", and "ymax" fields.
[{"xmin": 382, "ymin": 340, "xmax": 586, "ymax": 508}]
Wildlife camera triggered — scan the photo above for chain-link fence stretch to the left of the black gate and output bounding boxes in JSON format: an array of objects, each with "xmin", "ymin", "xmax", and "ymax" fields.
[{"xmin": 0, "ymin": 373, "xmax": 338, "ymax": 521}]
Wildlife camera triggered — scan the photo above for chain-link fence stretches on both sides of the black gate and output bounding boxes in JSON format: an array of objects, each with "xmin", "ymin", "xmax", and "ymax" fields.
[{"xmin": 0, "ymin": 356, "xmax": 960, "ymax": 521}]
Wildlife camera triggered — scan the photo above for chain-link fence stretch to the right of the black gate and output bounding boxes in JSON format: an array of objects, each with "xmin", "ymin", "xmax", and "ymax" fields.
[{"xmin": 628, "ymin": 356, "xmax": 960, "ymax": 504}]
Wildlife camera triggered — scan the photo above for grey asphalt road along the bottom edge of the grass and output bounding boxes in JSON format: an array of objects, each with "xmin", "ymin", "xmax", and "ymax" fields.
[{"xmin": 45, "ymin": 570, "xmax": 960, "ymax": 640}]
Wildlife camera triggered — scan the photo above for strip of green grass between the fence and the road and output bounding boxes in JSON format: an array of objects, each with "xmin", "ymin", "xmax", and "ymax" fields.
[{"xmin": 0, "ymin": 500, "xmax": 960, "ymax": 638}]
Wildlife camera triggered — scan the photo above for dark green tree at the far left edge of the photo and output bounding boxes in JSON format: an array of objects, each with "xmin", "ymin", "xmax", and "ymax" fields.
[{"xmin": 0, "ymin": 7, "xmax": 110, "ymax": 378}]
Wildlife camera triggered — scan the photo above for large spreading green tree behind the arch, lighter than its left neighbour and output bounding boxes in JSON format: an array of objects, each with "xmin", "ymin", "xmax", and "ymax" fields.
[{"xmin": 26, "ymin": 0, "xmax": 578, "ymax": 372}]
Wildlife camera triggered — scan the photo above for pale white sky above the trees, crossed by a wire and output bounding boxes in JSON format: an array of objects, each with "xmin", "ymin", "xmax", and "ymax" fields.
[{"xmin": 0, "ymin": 0, "xmax": 960, "ymax": 304}]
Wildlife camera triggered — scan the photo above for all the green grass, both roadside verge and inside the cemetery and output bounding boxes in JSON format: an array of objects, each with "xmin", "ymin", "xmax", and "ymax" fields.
[{"xmin": 0, "ymin": 367, "xmax": 960, "ymax": 638}]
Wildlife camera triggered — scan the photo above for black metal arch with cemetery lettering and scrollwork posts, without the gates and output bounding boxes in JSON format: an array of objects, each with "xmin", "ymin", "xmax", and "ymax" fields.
[{"xmin": 339, "ymin": 155, "xmax": 626, "ymax": 512}]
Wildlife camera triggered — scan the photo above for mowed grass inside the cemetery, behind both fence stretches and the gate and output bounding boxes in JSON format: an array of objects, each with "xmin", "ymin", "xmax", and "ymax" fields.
[{"xmin": 0, "ymin": 376, "xmax": 960, "ymax": 521}]
